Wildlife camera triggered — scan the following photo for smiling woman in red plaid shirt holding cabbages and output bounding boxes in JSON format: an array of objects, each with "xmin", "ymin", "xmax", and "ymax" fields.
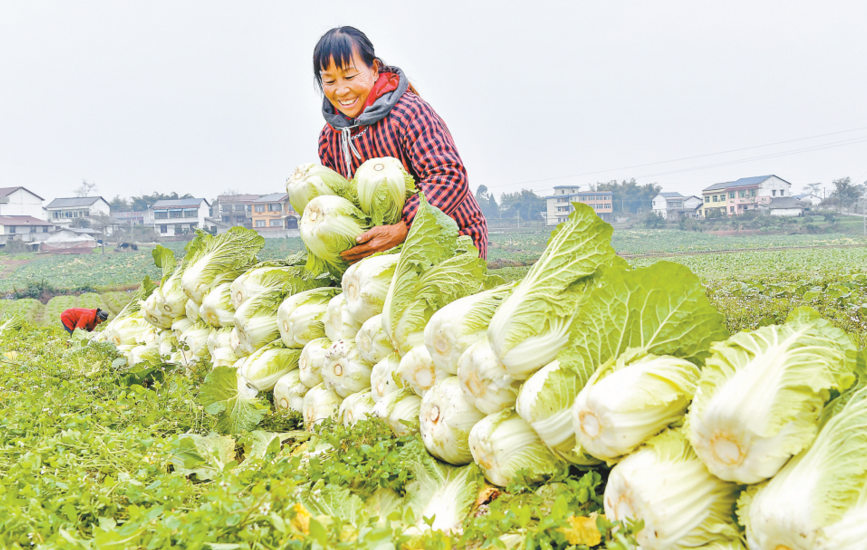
[{"xmin": 313, "ymin": 27, "xmax": 488, "ymax": 262}]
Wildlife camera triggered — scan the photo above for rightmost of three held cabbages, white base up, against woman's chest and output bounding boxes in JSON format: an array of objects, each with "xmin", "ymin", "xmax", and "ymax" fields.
[{"xmin": 353, "ymin": 157, "xmax": 418, "ymax": 225}]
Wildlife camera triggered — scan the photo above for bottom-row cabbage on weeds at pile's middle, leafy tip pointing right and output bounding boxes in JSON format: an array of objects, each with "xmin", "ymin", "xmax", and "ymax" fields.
[{"xmin": 469, "ymin": 409, "xmax": 564, "ymax": 487}]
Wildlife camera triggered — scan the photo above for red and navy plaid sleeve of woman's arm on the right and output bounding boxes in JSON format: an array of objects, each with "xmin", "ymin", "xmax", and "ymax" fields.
[{"xmin": 401, "ymin": 101, "xmax": 469, "ymax": 226}]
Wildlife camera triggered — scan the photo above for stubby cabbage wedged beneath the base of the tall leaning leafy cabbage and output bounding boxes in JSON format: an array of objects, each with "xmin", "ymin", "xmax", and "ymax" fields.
[{"xmin": 458, "ymin": 338, "xmax": 521, "ymax": 414}]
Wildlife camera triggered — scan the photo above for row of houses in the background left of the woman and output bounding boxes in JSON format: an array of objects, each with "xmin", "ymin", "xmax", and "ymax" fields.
[{"xmin": 0, "ymin": 186, "xmax": 298, "ymax": 244}]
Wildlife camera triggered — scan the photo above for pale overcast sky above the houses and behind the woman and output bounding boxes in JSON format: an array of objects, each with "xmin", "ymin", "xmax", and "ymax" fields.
[{"xmin": 0, "ymin": 0, "xmax": 867, "ymax": 206}]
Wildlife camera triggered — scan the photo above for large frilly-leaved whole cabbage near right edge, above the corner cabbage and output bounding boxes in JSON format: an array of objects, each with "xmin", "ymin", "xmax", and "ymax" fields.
[{"xmin": 687, "ymin": 308, "xmax": 856, "ymax": 483}]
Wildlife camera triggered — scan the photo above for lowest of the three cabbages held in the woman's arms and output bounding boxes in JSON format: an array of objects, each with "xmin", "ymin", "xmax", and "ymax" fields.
[{"xmin": 298, "ymin": 195, "xmax": 370, "ymax": 277}]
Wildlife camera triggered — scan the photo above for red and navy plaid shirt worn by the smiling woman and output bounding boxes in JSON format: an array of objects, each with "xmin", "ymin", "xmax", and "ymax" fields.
[{"xmin": 319, "ymin": 91, "xmax": 488, "ymax": 258}]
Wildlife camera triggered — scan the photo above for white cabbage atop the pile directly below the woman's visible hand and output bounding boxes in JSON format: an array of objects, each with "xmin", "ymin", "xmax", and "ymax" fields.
[{"xmin": 341, "ymin": 254, "xmax": 400, "ymax": 324}]
